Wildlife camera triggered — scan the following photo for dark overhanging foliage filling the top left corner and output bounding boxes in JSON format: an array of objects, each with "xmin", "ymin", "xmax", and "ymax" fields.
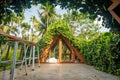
[{"xmin": 0, "ymin": 0, "xmax": 32, "ymax": 24}]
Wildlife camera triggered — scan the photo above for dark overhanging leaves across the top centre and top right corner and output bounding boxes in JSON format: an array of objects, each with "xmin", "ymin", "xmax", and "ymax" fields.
[{"xmin": 41, "ymin": 0, "xmax": 120, "ymax": 31}]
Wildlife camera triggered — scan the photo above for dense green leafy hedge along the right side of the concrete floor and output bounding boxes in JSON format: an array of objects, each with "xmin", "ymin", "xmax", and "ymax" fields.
[{"xmin": 80, "ymin": 33, "xmax": 120, "ymax": 76}]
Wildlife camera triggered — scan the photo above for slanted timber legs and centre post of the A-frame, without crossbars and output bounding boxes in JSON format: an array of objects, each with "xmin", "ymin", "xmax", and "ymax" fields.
[{"xmin": 40, "ymin": 35, "xmax": 85, "ymax": 63}]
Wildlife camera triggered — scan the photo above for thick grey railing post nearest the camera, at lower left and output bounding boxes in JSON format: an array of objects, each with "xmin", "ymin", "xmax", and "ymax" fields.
[{"xmin": 10, "ymin": 41, "xmax": 18, "ymax": 80}]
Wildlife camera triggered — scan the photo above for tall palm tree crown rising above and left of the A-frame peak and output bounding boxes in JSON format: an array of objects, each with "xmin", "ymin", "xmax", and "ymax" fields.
[{"xmin": 38, "ymin": 2, "xmax": 57, "ymax": 34}]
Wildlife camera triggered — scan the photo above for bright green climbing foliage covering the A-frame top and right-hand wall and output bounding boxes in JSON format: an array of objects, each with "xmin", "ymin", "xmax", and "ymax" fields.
[{"xmin": 38, "ymin": 20, "xmax": 120, "ymax": 76}]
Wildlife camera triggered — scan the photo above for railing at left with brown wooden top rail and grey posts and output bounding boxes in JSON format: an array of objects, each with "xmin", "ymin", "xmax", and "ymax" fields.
[{"xmin": 0, "ymin": 30, "xmax": 40, "ymax": 80}]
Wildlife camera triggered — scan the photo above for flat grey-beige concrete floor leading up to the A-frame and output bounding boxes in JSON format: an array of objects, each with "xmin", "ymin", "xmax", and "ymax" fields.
[{"xmin": 0, "ymin": 64, "xmax": 120, "ymax": 80}]
